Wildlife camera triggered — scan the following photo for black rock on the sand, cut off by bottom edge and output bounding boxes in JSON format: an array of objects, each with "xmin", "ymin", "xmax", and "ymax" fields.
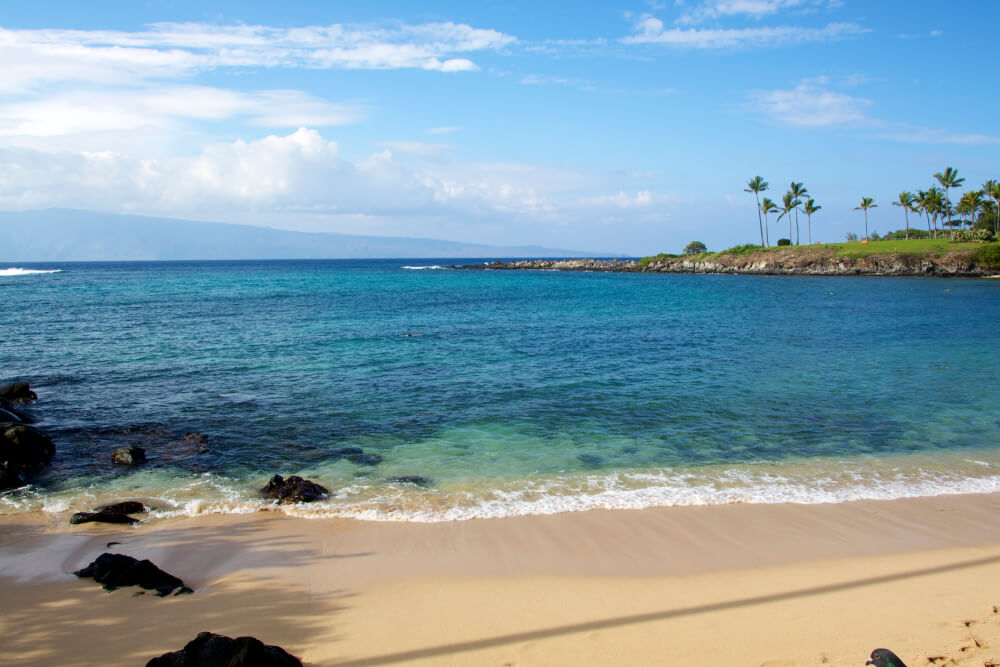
[{"xmin": 146, "ymin": 632, "xmax": 302, "ymax": 667}]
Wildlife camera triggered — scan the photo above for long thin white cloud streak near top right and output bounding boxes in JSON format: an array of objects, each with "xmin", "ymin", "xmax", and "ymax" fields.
[{"xmin": 621, "ymin": 16, "xmax": 868, "ymax": 49}]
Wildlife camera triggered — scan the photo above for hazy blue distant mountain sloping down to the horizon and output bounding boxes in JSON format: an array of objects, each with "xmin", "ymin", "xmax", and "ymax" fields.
[{"xmin": 0, "ymin": 209, "xmax": 607, "ymax": 262}]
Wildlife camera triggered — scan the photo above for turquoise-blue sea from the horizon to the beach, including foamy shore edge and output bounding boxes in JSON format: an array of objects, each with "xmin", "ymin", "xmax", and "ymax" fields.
[{"xmin": 0, "ymin": 260, "xmax": 1000, "ymax": 521}]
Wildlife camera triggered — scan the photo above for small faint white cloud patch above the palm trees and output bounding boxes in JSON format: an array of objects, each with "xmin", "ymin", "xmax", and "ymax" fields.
[{"xmin": 751, "ymin": 77, "xmax": 872, "ymax": 127}]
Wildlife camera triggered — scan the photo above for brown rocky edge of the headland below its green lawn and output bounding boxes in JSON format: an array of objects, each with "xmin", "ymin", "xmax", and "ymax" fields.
[{"xmin": 450, "ymin": 248, "xmax": 1000, "ymax": 277}]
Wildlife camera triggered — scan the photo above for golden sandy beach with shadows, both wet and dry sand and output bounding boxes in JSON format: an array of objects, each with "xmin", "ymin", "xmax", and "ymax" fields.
[{"xmin": 0, "ymin": 494, "xmax": 1000, "ymax": 667}]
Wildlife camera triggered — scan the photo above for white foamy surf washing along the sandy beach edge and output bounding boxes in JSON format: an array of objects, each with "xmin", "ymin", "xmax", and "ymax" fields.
[{"xmin": 13, "ymin": 462, "xmax": 1000, "ymax": 523}]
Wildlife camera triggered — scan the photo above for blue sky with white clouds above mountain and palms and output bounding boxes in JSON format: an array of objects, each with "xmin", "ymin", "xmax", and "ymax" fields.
[{"xmin": 0, "ymin": 0, "xmax": 1000, "ymax": 256}]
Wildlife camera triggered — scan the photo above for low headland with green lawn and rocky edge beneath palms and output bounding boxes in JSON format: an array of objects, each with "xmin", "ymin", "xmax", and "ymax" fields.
[{"xmin": 455, "ymin": 239, "xmax": 1000, "ymax": 277}]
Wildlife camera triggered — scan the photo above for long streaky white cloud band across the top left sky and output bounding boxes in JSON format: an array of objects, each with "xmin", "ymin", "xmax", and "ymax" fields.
[{"xmin": 0, "ymin": 23, "xmax": 516, "ymax": 92}]
